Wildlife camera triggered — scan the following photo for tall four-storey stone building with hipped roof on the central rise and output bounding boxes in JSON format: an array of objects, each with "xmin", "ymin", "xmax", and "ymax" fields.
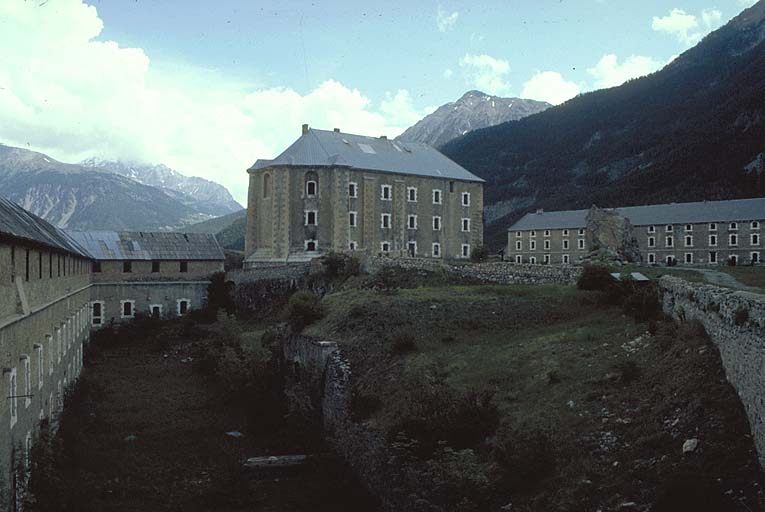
[{"xmin": 245, "ymin": 125, "xmax": 483, "ymax": 266}]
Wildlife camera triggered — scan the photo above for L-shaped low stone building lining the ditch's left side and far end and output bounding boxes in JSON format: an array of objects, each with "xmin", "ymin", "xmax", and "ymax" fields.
[{"xmin": 0, "ymin": 198, "xmax": 224, "ymax": 512}]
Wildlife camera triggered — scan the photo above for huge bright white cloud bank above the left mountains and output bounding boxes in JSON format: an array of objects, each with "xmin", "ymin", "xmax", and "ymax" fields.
[{"xmin": 0, "ymin": 0, "xmax": 423, "ymax": 203}]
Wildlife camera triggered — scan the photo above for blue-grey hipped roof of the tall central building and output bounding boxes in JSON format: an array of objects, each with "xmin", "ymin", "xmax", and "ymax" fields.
[{"xmin": 251, "ymin": 129, "xmax": 483, "ymax": 182}]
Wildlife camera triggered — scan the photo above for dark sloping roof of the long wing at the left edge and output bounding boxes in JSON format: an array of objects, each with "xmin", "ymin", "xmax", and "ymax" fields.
[{"xmin": 0, "ymin": 197, "xmax": 90, "ymax": 258}]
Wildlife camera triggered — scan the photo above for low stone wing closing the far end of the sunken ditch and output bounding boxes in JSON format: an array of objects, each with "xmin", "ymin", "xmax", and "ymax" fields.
[{"xmin": 69, "ymin": 231, "xmax": 224, "ymax": 327}]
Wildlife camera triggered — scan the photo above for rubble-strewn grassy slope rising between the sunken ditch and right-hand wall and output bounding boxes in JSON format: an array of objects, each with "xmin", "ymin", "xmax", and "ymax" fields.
[{"xmin": 305, "ymin": 280, "xmax": 765, "ymax": 512}]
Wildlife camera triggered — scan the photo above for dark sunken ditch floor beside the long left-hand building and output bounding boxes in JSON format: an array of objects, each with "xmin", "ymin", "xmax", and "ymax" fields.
[{"xmin": 25, "ymin": 319, "xmax": 375, "ymax": 512}]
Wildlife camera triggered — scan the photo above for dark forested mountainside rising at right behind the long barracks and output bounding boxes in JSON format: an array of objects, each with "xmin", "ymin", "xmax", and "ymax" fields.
[{"xmin": 442, "ymin": 0, "xmax": 765, "ymax": 247}]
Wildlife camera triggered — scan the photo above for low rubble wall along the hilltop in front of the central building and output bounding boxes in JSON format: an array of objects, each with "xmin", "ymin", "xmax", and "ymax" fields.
[{"xmin": 363, "ymin": 256, "xmax": 582, "ymax": 284}]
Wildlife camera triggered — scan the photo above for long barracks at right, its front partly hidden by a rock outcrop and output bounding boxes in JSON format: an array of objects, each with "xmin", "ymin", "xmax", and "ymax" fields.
[{"xmin": 507, "ymin": 198, "xmax": 765, "ymax": 265}]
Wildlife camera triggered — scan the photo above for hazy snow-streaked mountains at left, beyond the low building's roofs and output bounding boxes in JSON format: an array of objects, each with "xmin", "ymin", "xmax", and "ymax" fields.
[{"xmin": 0, "ymin": 144, "xmax": 241, "ymax": 230}]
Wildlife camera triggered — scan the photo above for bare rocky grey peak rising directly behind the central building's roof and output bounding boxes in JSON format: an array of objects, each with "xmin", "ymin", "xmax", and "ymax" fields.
[{"xmin": 396, "ymin": 91, "xmax": 552, "ymax": 148}]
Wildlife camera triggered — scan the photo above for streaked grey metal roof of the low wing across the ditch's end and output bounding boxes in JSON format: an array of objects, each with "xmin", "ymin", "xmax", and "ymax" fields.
[{"xmin": 68, "ymin": 231, "xmax": 224, "ymax": 260}]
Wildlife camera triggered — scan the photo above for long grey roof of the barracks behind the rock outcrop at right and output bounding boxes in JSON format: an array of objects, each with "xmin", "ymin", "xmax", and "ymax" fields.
[{"xmin": 509, "ymin": 197, "xmax": 765, "ymax": 231}]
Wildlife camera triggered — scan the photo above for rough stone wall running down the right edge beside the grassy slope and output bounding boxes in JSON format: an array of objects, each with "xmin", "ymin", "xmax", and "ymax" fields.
[{"xmin": 659, "ymin": 277, "xmax": 765, "ymax": 467}]
